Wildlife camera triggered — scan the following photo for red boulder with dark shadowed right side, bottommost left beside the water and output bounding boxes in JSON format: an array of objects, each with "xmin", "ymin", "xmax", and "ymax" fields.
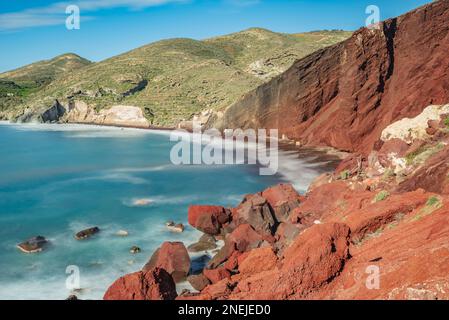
[{"xmin": 103, "ymin": 268, "xmax": 177, "ymax": 300}]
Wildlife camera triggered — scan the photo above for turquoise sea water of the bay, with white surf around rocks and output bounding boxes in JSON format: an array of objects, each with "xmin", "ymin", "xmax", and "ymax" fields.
[{"xmin": 0, "ymin": 124, "xmax": 322, "ymax": 299}]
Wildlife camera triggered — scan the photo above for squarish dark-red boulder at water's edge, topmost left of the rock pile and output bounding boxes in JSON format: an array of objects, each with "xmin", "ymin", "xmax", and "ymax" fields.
[{"xmin": 188, "ymin": 206, "xmax": 230, "ymax": 235}]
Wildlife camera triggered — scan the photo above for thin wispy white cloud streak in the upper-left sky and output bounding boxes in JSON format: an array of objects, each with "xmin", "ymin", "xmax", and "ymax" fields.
[{"xmin": 0, "ymin": 0, "xmax": 187, "ymax": 31}]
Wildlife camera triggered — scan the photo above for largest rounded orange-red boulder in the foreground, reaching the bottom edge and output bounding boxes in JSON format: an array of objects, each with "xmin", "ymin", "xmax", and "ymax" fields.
[{"xmin": 228, "ymin": 223, "xmax": 350, "ymax": 300}]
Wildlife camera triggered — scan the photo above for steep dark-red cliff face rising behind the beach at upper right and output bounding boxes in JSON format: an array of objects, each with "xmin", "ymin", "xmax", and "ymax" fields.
[{"xmin": 213, "ymin": 1, "xmax": 449, "ymax": 152}]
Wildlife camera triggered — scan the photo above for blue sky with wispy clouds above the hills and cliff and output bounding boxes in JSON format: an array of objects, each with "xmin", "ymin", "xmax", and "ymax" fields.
[{"xmin": 0, "ymin": 0, "xmax": 431, "ymax": 72}]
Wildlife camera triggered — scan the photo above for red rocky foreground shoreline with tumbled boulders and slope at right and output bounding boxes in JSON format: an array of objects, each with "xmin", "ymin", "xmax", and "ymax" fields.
[{"xmin": 104, "ymin": 106, "xmax": 449, "ymax": 300}]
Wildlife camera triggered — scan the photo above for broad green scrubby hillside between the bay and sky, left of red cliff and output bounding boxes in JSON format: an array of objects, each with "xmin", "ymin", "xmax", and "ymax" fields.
[{"xmin": 0, "ymin": 29, "xmax": 350, "ymax": 126}]
